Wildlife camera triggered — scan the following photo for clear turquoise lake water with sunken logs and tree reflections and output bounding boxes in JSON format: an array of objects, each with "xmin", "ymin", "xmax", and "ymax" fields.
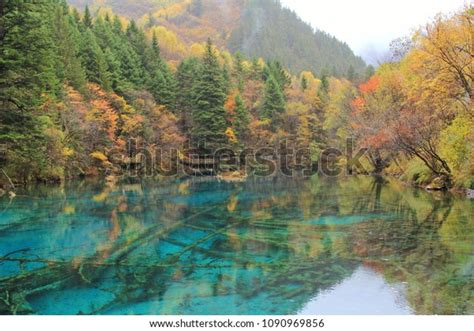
[{"xmin": 0, "ymin": 177, "xmax": 474, "ymax": 315}]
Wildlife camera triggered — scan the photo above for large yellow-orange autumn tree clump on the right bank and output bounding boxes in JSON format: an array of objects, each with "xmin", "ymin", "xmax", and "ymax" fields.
[{"xmin": 346, "ymin": 9, "xmax": 473, "ymax": 187}]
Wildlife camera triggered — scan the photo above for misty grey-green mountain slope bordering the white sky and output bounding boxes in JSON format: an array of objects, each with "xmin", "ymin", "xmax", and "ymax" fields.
[{"xmin": 228, "ymin": 0, "xmax": 365, "ymax": 75}]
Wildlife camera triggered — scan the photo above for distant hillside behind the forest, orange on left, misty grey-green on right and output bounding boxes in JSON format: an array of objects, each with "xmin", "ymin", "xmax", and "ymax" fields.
[{"xmin": 69, "ymin": 0, "xmax": 365, "ymax": 76}]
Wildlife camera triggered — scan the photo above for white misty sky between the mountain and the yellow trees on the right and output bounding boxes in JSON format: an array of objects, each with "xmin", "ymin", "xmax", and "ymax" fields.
[{"xmin": 280, "ymin": 0, "xmax": 468, "ymax": 64}]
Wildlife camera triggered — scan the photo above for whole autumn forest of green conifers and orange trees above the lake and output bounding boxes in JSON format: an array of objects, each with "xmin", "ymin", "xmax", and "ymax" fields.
[{"xmin": 0, "ymin": 0, "xmax": 474, "ymax": 189}]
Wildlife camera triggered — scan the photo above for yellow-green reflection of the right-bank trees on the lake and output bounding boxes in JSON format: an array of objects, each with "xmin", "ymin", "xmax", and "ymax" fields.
[{"xmin": 350, "ymin": 179, "xmax": 474, "ymax": 314}]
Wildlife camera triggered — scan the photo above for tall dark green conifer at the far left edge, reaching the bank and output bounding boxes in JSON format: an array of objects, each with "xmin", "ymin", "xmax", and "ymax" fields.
[{"xmin": 0, "ymin": 1, "xmax": 60, "ymax": 181}]
